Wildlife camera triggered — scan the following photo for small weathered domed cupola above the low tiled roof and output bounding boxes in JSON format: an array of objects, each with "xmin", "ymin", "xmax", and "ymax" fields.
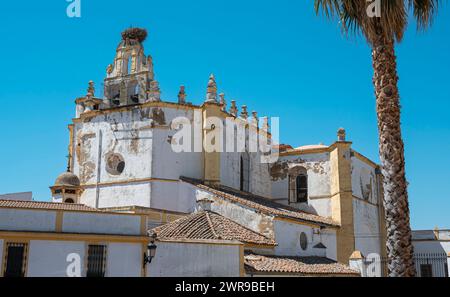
[{"xmin": 50, "ymin": 171, "xmax": 82, "ymax": 203}]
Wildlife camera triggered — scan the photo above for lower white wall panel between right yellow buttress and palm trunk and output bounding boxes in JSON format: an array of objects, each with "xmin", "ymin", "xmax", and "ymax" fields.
[{"xmin": 353, "ymin": 199, "xmax": 381, "ymax": 256}]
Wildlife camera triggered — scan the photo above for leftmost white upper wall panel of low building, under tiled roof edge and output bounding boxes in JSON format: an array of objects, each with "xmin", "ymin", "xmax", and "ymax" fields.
[{"xmin": 0, "ymin": 208, "xmax": 56, "ymax": 231}]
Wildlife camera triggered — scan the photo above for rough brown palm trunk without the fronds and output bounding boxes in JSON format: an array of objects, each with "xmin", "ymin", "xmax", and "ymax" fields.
[{"xmin": 372, "ymin": 37, "xmax": 415, "ymax": 276}]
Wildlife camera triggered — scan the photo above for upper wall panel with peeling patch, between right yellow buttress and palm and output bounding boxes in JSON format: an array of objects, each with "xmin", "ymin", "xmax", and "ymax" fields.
[{"xmin": 351, "ymin": 157, "xmax": 378, "ymax": 204}]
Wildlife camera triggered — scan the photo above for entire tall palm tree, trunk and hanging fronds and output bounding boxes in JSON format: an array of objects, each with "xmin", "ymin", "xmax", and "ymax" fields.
[{"xmin": 314, "ymin": 0, "xmax": 440, "ymax": 276}]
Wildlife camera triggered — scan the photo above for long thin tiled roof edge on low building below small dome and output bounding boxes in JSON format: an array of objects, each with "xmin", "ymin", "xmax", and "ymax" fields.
[{"xmin": 0, "ymin": 200, "xmax": 100, "ymax": 212}]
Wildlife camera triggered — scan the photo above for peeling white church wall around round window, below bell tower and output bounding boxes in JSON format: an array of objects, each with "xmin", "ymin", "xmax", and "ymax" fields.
[{"xmin": 73, "ymin": 107, "xmax": 203, "ymax": 211}]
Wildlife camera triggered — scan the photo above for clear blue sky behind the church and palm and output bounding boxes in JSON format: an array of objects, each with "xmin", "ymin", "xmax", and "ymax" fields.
[{"xmin": 0, "ymin": 0, "xmax": 450, "ymax": 229}]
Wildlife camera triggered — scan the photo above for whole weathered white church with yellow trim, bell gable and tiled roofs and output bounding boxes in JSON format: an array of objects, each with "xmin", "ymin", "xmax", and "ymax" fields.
[{"xmin": 0, "ymin": 28, "xmax": 385, "ymax": 276}]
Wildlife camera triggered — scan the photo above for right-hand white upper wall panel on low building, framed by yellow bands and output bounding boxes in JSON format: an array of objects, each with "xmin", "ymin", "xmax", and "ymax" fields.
[{"xmin": 62, "ymin": 212, "xmax": 141, "ymax": 235}]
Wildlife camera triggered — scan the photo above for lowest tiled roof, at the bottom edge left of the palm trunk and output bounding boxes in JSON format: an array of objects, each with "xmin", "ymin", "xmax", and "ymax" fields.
[{"xmin": 244, "ymin": 254, "xmax": 359, "ymax": 276}]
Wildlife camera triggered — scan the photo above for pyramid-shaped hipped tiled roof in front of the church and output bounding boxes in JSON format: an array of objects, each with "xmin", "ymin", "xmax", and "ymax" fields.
[{"xmin": 153, "ymin": 210, "xmax": 276, "ymax": 246}]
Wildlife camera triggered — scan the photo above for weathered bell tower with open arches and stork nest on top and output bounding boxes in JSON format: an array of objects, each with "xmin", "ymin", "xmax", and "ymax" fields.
[{"xmin": 104, "ymin": 28, "xmax": 160, "ymax": 108}]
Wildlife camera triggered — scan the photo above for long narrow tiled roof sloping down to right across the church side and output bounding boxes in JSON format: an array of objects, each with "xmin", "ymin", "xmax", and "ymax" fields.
[{"xmin": 180, "ymin": 177, "xmax": 339, "ymax": 226}]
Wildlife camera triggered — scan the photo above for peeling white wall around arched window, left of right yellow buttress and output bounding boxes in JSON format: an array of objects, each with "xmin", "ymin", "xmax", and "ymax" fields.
[{"xmin": 270, "ymin": 153, "xmax": 331, "ymax": 217}]
